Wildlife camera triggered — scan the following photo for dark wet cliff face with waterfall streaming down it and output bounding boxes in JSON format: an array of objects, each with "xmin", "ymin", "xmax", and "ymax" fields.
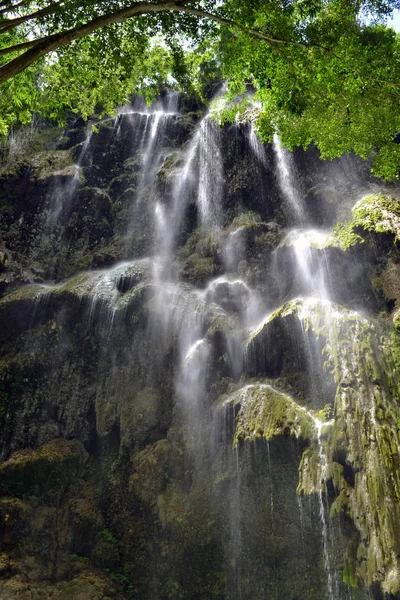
[{"xmin": 0, "ymin": 94, "xmax": 400, "ymax": 600}]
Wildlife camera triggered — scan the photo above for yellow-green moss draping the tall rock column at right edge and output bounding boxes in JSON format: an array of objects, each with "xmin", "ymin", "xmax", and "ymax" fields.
[{"xmin": 248, "ymin": 299, "xmax": 400, "ymax": 593}]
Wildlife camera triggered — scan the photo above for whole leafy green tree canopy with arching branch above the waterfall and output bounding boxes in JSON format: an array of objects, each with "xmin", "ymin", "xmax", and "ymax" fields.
[{"xmin": 0, "ymin": 0, "xmax": 400, "ymax": 179}]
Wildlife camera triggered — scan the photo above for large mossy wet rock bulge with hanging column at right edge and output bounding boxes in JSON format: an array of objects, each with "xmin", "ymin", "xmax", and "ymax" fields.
[{"xmin": 247, "ymin": 299, "xmax": 400, "ymax": 593}]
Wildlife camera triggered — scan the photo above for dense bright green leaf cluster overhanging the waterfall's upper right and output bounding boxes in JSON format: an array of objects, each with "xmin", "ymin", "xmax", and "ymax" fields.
[{"xmin": 212, "ymin": 1, "xmax": 400, "ymax": 179}]
